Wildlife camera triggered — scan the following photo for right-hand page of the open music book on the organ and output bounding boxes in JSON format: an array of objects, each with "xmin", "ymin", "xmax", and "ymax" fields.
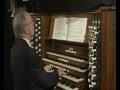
[{"xmin": 67, "ymin": 17, "xmax": 87, "ymax": 42}]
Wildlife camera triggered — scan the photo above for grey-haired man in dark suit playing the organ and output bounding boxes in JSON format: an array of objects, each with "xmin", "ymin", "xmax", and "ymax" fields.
[{"xmin": 10, "ymin": 8, "xmax": 66, "ymax": 90}]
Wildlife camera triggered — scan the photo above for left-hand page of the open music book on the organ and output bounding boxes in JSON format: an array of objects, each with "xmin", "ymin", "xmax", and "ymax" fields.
[{"xmin": 52, "ymin": 18, "xmax": 68, "ymax": 40}]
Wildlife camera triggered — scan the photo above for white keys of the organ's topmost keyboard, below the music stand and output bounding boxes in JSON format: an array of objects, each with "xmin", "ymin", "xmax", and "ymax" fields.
[{"xmin": 47, "ymin": 52, "xmax": 88, "ymax": 63}]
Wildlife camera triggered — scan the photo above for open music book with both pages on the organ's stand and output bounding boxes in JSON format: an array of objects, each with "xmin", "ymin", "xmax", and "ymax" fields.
[{"xmin": 52, "ymin": 17, "xmax": 87, "ymax": 42}]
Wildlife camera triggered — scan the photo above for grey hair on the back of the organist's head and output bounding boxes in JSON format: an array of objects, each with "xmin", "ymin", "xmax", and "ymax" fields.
[{"xmin": 13, "ymin": 7, "xmax": 26, "ymax": 38}]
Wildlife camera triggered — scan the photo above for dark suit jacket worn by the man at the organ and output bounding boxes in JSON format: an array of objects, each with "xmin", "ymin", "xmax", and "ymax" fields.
[{"xmin": 10, "ymin": 39, "xmax": 59, "ymax": 90}]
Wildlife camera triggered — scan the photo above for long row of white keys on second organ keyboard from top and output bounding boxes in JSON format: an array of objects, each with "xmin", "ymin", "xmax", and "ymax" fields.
[{"xmin": 42, "ymin": 58, "xmax": 87, "ymax": 73}]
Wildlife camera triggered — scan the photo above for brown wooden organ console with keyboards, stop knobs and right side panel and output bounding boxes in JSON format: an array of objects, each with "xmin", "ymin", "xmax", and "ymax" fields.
[{"xmin": 31, "ymin": 6, "xmax": 116, "ymax": 90}]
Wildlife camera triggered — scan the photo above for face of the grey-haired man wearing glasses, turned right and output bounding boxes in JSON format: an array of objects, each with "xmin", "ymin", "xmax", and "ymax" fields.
[{"xmin": 25, "ymin": 12, "xmax": 34, "ymax": 39}]
